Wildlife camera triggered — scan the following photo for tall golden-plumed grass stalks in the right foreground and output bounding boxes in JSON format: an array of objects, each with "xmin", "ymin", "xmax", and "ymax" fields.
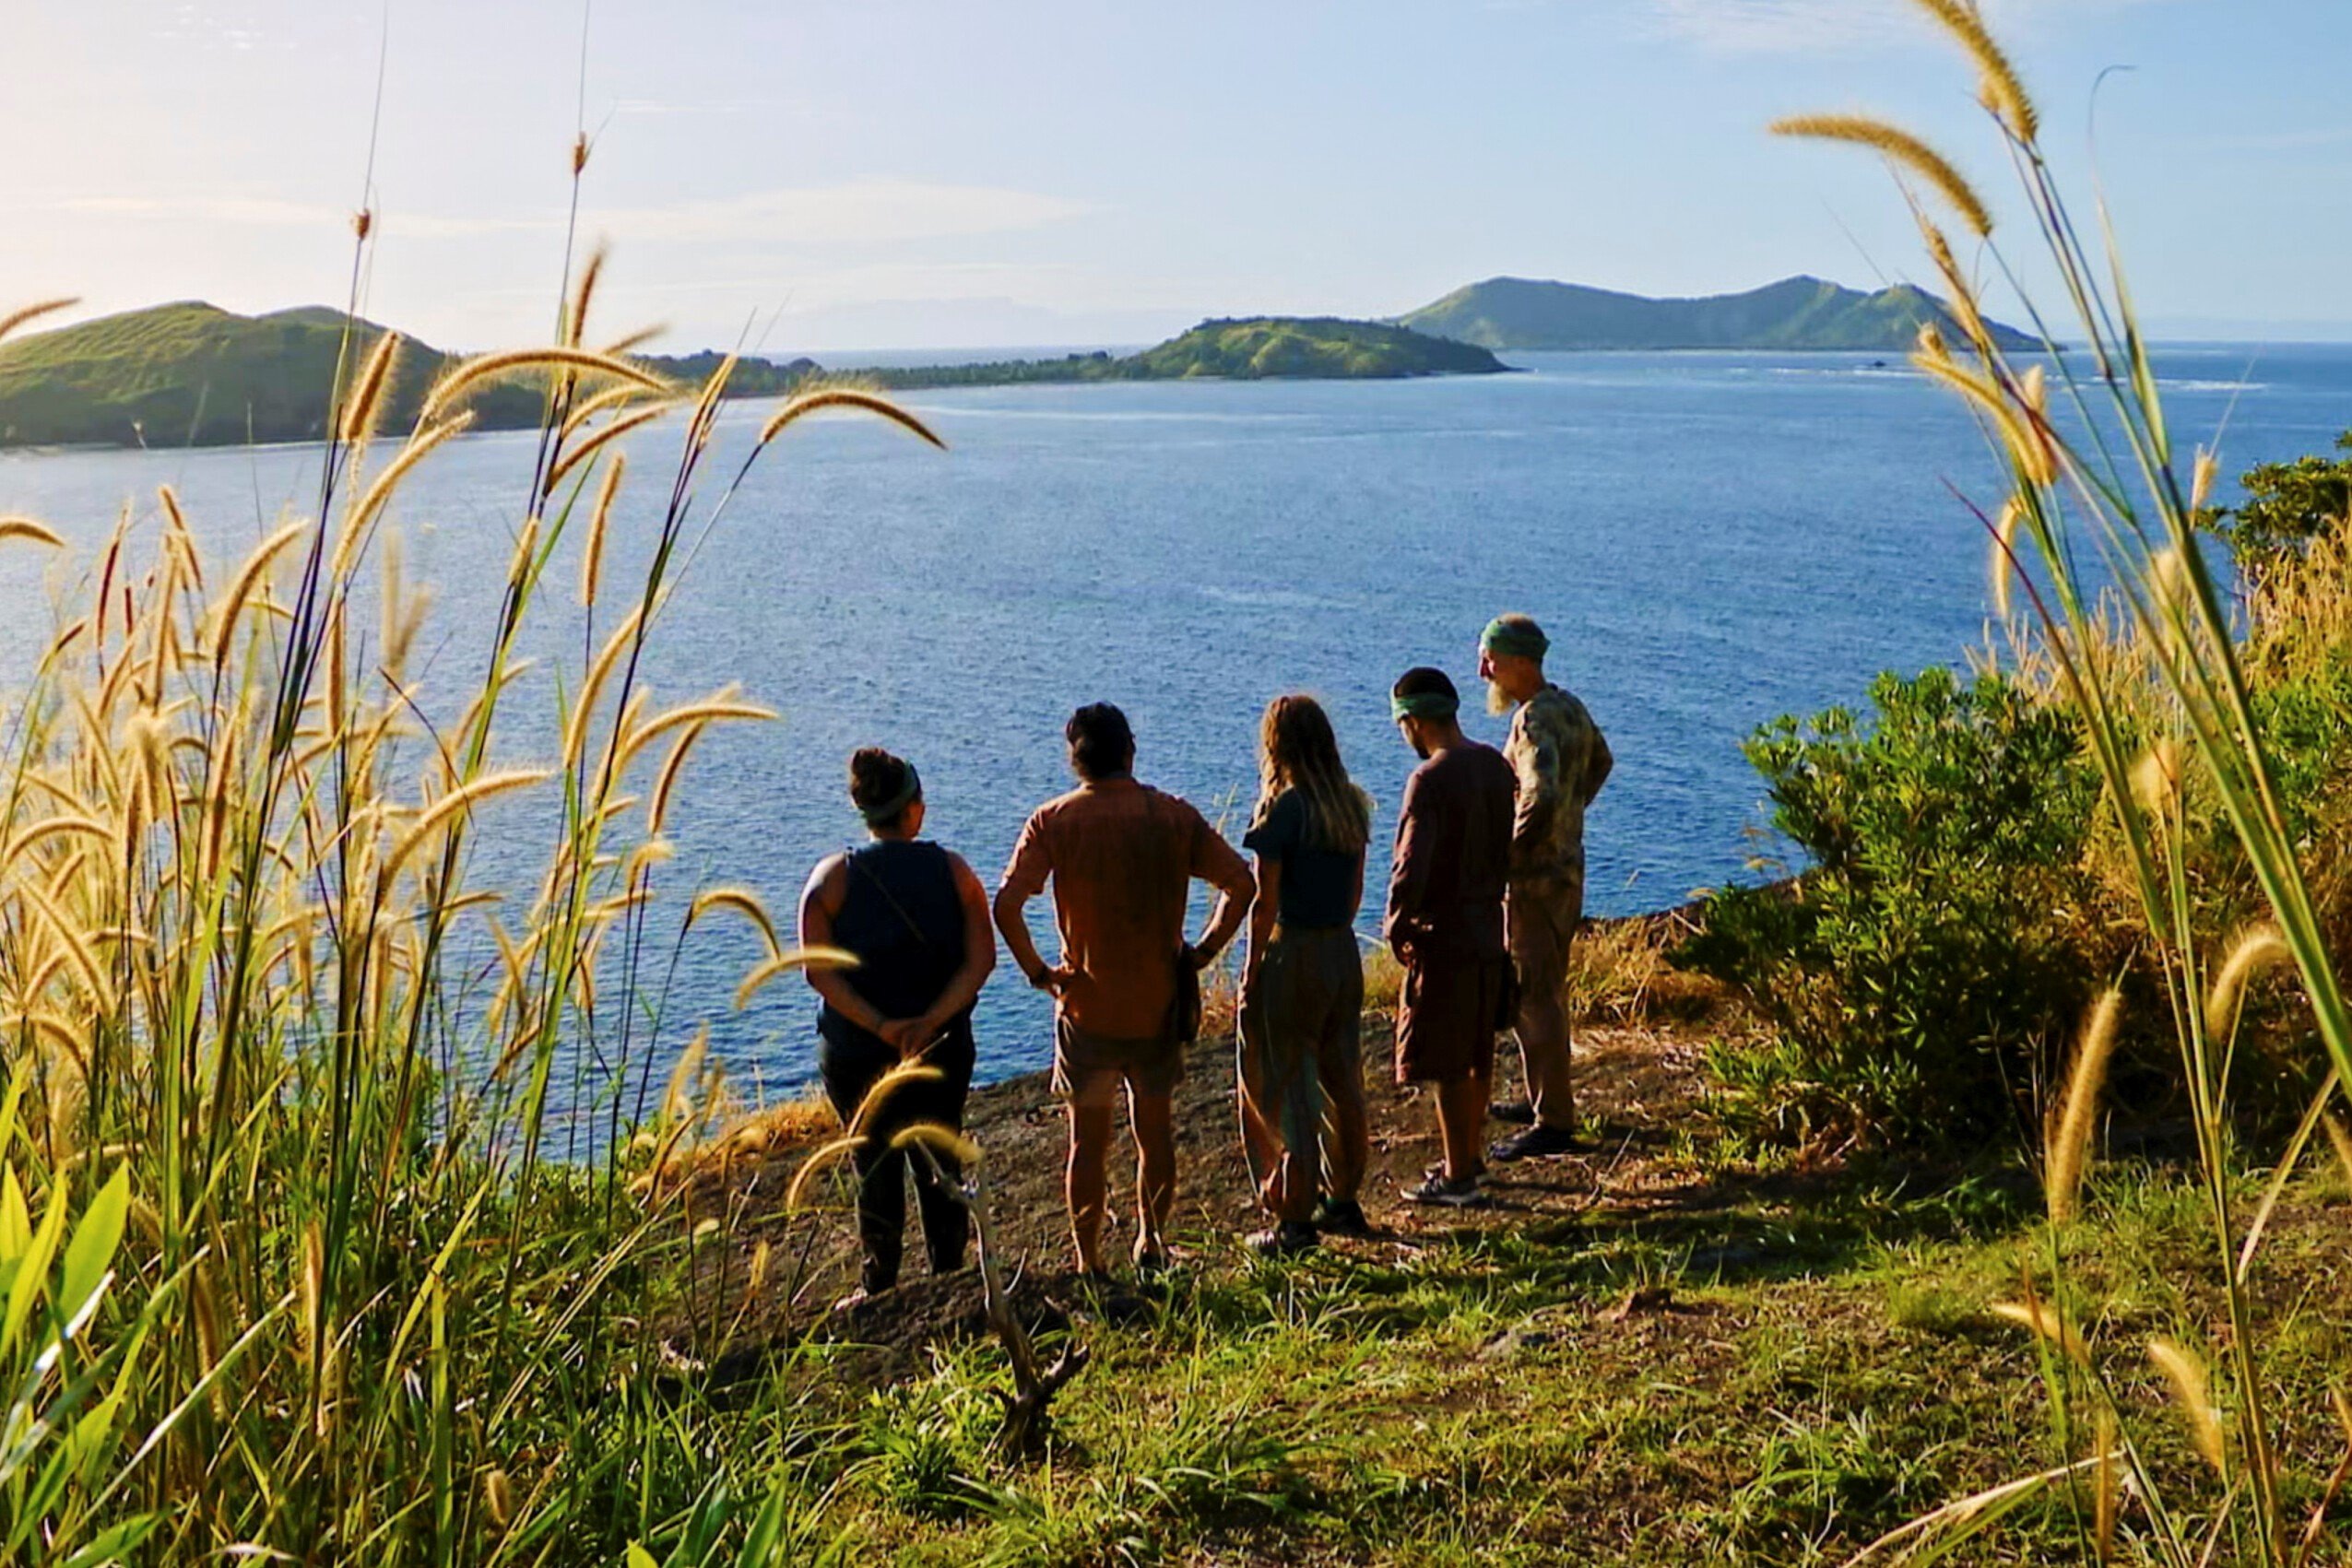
[{"xmin": 1776, "ymin": 0, "xmax": 2352, "ymax": 1568}]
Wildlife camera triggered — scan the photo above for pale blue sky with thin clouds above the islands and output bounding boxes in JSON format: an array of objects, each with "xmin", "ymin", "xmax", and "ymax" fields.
[{"xmin": 0, "ymin": 0, "xmax": 2352, "ymax": 358}]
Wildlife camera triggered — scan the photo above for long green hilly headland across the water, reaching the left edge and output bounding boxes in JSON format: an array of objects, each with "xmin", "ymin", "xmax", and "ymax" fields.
[{"xmin": 0, "ymin": 301, "xmax": 1506, "ymax": 447}]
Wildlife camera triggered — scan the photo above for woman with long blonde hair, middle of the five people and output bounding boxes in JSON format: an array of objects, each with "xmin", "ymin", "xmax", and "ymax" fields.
[{"xmin": 1237, "ymin": 693, "xmax": 1371, "ymax": 1253}]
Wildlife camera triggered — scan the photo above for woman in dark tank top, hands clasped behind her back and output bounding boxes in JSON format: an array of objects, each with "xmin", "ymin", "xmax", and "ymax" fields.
[{"xmin": 799, "ymin": 745, "xmax": 998, "ymax": 1307}]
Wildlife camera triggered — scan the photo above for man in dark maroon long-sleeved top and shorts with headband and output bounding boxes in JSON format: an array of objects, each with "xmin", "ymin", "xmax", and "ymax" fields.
[{"xmin": 1386, "ymin": 667, "xmax": 1515, "ymax": 1206}]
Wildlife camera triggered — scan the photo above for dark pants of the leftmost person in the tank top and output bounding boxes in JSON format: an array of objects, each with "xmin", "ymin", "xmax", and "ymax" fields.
[{"xmin": 816, "ymin": 1030, "xmax": 972, "ymax": 1291}]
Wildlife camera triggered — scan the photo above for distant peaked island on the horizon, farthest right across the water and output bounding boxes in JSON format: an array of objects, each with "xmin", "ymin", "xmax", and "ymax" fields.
[{"xmin": 1397, "ymin": 277, "xmax": 2041, "ymax": 353}]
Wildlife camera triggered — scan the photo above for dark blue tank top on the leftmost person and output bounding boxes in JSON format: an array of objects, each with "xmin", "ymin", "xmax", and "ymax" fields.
[{"xmin": 819, "ymin": 839, "xmax": 972, "ymax": 1039}]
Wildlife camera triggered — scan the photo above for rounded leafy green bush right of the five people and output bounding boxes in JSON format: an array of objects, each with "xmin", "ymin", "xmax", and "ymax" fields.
[{"xmin": 1677, "ymin": 670, "xmax": 2105, "ymax": 1142}]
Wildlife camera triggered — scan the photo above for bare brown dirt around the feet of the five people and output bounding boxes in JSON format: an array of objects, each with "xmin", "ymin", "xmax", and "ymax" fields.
[{"xmin": 687, "ymin": 992, "xmax": 1740, "ymax": 1359}]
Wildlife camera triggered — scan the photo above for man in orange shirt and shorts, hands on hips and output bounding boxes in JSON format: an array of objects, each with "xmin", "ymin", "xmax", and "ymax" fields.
[{"xmin": 995, "ymin": 703, "xmax": 1256, "ymax": 1274}]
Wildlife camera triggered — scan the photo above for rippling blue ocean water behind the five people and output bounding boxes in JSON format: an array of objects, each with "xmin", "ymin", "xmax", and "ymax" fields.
[{"xmin": 0, "ymin": 346, "xmax": 2352, "ymax": 1095}]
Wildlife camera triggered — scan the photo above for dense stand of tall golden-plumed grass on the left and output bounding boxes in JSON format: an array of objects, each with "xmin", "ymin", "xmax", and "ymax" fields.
[{"xmin": 0, "ymin": 193, "xmax": 936, "ymax": 1563}]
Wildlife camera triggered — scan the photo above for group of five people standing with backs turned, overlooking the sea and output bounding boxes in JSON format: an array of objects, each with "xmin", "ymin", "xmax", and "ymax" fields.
[{"xmin": 799, "ymin": 616, "xmax": 1611, "ymax": 1300}]
